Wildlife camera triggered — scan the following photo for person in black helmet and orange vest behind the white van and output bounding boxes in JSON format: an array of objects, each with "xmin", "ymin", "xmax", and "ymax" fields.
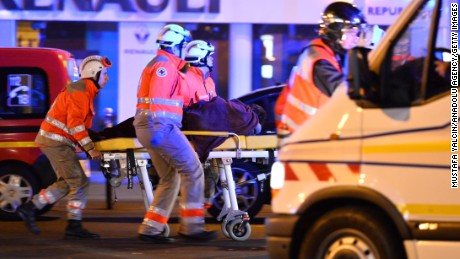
[{"xmin": 275, "ymin": 2, "xmax": 366, "ymax": 142}]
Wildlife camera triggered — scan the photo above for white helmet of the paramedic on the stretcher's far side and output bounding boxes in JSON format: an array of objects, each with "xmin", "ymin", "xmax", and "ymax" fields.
[{"xmin": 185, "ymin": 40, "xmax": 215, "ymax": 66}]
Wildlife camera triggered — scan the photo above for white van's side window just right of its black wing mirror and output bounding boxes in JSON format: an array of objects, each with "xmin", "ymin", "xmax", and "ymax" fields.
[{"xmin": 382, "ymin": 0, "xmax": 436, "ymax": 107}]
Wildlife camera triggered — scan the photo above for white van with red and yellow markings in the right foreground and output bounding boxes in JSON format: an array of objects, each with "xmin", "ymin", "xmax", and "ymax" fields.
[{"xmin": 265, "ymin": 0, "xmax": 460, "ymax": 259}]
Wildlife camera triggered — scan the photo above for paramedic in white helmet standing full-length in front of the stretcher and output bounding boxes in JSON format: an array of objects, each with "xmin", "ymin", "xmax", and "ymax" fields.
[{"xmin": 133, "ymin": 24, "xmax": 217, "ymax": 243}]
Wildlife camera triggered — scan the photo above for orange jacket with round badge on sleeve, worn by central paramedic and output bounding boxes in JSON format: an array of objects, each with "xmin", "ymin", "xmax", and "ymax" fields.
[{"xmin": 136, "ymin": 49, "xmax": 187, "ymax": 127}]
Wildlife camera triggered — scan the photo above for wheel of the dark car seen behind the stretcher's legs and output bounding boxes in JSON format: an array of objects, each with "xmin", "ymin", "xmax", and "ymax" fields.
[{"xmin": 208, "ymin": 161, "xmax": 270, "ymax": 219}]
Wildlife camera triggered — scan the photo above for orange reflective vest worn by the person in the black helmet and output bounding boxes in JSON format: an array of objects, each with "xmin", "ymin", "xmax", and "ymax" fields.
[{"xmin": 275, "ymin": 38, "xmax": 342, "ymax": 134}]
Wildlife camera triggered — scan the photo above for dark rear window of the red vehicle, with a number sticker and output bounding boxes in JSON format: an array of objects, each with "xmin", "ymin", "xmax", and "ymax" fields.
[{"xmin": 0, "ymin": 67, "xmax": 49, "ymax": 119}]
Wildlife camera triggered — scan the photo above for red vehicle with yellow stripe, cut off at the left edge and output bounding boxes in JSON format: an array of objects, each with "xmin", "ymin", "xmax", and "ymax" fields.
[{"xmin": 0, "ymin": 48, "xmax": 78, "ymax": 220}]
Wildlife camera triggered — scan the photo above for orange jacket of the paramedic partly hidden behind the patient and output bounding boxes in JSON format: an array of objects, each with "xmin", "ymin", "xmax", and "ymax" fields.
[{"xmin": 182, "ymin": 67, "xmax": 217, "ymax": 106}]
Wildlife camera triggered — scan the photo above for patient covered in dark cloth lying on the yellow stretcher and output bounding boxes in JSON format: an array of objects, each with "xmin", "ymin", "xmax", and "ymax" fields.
[{"xmin": 90, "ymin": 96, "xmax": 266, "ymax": 162}]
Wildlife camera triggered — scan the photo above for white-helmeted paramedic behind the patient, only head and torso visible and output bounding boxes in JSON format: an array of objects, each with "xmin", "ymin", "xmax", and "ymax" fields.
[{"xmin": 183, "ymin": 40, "xmax": 217, "ymax": 106}]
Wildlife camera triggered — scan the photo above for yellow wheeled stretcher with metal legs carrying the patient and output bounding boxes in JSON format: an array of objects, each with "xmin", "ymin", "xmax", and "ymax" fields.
[{"xmin": 83, "ymin": 131, "xmax": 277, "ymax": 241}]
